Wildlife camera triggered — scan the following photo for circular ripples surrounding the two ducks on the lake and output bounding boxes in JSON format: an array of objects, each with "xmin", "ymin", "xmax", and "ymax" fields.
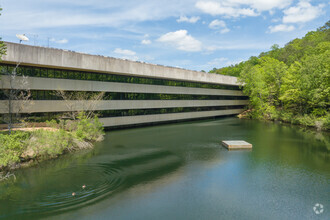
[{"xmin": 20, "ymin": 164, "xmax": 124, "ymax": 213}]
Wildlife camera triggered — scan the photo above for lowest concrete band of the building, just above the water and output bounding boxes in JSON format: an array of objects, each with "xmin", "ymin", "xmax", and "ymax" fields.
[{"xmin": 100, "ymin": 109, "xmax": 243, "ymax": 127}]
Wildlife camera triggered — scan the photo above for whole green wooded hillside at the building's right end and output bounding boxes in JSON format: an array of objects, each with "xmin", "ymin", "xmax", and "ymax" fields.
[{"xmin": 210, "ymin": 21, "xmax": 330, "ymax": 130}]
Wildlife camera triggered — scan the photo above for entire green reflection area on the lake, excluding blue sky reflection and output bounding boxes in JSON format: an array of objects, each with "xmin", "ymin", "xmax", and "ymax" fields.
[{"xmin": 0, "ymin": 119, "xmax": 329, "ymax": 218}]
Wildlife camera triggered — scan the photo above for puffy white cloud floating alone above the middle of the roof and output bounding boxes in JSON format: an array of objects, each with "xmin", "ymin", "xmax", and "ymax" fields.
[{"xmin": 157, "ymin": 30, "xmax": 202, "ymax": 52}]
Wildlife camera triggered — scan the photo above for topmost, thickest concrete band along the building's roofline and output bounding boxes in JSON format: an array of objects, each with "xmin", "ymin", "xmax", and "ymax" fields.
[{"xmin": 2, "ymin": 42, "xmax": 239, "ymax": 85}]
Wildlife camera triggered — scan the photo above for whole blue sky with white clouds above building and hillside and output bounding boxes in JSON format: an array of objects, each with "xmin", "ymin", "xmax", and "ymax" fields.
[{"xmin": 0, "ymin": 0, "xmax": 330, "ymax": 71}]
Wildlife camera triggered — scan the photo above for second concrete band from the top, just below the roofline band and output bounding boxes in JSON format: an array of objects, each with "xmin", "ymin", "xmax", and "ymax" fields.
[{"xmin": 0, "ymin": 76, "xmax": 244, "ymax": 96}]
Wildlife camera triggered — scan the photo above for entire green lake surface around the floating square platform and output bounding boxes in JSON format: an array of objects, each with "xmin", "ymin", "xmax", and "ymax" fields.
[{"xmin": 0, "ymin": 118, "xmax": 330, "ymax": 220}]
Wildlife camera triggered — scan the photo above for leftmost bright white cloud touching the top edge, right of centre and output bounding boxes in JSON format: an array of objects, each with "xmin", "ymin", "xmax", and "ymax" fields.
[{"xmin": 195, "ymin": 1, "xmax": 259, "ymax": 17}]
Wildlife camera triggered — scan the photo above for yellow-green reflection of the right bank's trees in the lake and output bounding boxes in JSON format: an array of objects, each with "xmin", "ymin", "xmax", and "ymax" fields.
[{"xmin": 250, "ymin": 123, "xmax": 330, "ymax": 172}]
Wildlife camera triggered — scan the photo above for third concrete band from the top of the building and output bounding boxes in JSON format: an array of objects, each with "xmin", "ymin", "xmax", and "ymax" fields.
[{"xmin": 0, "ymin": 100, "xmax": 248, "ymax": 114}]
